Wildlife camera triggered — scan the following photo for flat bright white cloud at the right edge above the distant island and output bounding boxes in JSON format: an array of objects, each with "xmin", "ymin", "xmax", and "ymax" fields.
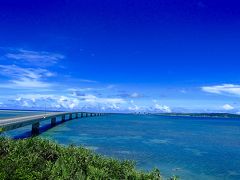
[{"xmin": 201, "ymin": 84, "xmax": 240, "ymax": 96}]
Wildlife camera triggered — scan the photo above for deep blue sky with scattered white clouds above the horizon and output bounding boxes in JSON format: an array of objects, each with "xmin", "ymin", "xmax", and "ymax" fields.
[{"xmin": 0, "ymin": 0, "xmax": 240, "ymax": 113}]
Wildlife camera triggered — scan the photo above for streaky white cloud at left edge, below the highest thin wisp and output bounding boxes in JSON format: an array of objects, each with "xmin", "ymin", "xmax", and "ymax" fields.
[{"xmin": 0, "ymin": 65, "xmax": 54, "ymax": 88}]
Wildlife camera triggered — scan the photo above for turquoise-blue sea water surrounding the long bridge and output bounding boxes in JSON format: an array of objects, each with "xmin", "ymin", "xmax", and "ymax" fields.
[{"xmin": 0, "ymin": 111, "xmax": 240, "ymax": 180}]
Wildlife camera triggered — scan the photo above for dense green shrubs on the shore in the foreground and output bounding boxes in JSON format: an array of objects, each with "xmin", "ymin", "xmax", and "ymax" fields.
[{"xmin": 0, "ymin": 137, "xmax": 175, "ymax": 180}]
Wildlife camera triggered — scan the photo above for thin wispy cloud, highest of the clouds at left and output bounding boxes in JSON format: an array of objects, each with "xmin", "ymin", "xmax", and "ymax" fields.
[{"xmin": 5, "ymin": 49, "xmax": 64, "ymax": 67}]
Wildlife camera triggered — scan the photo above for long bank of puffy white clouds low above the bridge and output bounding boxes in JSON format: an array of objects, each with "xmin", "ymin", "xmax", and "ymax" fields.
[{"xmin": 8, "ymin": 94, "xmax": 125, "ymax": 110}]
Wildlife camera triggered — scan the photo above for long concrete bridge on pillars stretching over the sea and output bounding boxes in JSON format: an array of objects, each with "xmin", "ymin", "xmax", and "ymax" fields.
[{"xmin": 0, "ymin": 112, "xmax": 104, "ymax": 135}]
